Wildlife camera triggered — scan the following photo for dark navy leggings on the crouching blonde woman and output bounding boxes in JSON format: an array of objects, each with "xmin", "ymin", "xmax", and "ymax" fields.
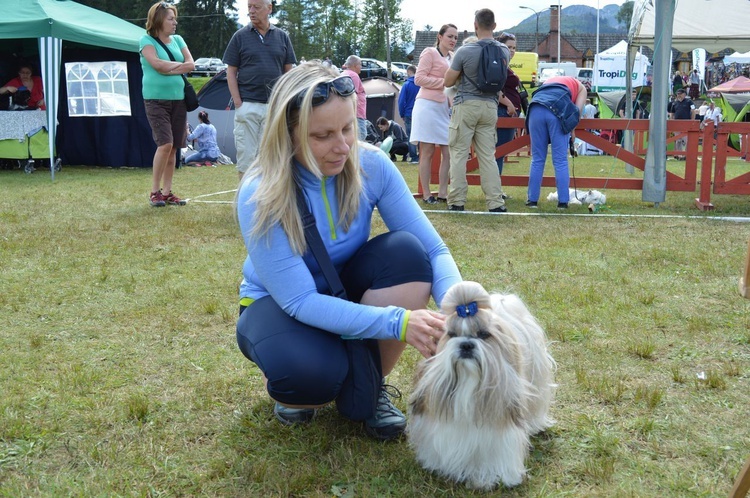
[{"xmin": 237, "ymin": 232, "xmax": 432, "ymax": 405}]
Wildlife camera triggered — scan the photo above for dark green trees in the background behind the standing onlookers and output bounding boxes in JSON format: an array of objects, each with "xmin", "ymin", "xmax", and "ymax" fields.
[{"xmin": 76, "ymin": 0, "xmax": 413, "ymax": 66}]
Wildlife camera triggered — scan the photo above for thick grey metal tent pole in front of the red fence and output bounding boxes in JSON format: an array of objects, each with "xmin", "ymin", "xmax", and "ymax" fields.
[{"xmin": 631, "ymin": 0, "xmax": 676, "ymax": 207}]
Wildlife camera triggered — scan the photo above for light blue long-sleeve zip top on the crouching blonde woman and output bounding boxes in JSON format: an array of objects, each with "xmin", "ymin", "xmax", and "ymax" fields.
[{"xmin": 237, "ymin": 146, "xmax": 461, "ymax": 339}]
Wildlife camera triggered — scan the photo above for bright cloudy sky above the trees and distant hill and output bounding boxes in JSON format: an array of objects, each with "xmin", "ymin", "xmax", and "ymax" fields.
[{"xmin": 236, "ymin": 0, "xmax": 624, "ymax": 33}]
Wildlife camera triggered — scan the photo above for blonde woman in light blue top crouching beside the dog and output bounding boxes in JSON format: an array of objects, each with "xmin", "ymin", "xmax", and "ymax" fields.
[{"xmin": 236, "ymin": 62, "xmax": 461, "ymax": 439}]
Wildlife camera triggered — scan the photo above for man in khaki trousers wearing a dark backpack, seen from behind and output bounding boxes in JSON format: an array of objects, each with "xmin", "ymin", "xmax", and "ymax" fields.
[{"xmin": 445, "ymin": 9, "xmax": 510, "ymax": 213}]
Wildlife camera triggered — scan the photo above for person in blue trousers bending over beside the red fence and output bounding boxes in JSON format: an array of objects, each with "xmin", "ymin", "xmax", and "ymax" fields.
[{"xmin": 526, "ymin": 76, "xmax": 588, "ymax": 209}]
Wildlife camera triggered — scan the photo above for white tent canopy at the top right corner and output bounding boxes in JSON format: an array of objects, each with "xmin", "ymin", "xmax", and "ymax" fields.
[{"xmin": 629, "ymin": 0, "xmax": 750, "ymax": 52}]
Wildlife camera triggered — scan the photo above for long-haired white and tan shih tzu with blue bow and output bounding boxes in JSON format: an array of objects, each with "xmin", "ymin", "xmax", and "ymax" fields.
[{"xmin": 407, "ymin": 282, "xmax": 555, "ymax": 490}]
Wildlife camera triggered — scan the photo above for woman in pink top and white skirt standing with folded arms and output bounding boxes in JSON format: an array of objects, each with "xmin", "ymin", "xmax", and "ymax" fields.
[{"xmin": 410, "ymin": 24, "xmax": 458, "ymax": 204}]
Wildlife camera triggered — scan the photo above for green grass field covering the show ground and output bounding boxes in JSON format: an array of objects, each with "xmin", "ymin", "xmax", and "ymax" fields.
[{"xmin": 0, "ymin": 157, "xmax": 750, "ymax": 498}]
